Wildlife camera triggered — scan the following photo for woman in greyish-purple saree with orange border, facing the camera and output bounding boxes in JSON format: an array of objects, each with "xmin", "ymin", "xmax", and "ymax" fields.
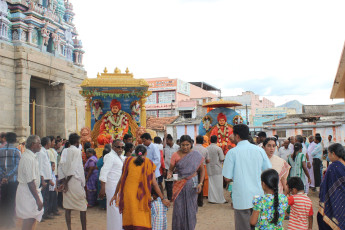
[{"xmin": 168, "ymin": 135, "xmax": 205, "ymax": 230}]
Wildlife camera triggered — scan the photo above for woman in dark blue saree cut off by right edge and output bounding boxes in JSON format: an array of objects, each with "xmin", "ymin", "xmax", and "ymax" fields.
[{"xmin": 317, "ymin": 143, "xmax": 345, "ymax": 230}]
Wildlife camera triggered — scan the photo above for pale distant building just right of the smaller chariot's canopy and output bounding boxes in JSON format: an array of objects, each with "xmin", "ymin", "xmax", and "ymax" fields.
[{"xmin": 223, "ymin": 91, "xmax": 274, "ymax": 128}]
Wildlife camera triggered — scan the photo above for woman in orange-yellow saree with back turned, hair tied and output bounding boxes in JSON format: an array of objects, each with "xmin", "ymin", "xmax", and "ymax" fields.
[{"xmin": 110, "ymin": 145, "xmax": 170, "ymax": 230}]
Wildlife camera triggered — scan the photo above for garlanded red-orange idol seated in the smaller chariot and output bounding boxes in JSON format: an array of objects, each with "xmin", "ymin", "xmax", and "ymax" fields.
[{"xmin": 210, "ymin": 113, "xmax": 234, "ymax": 154}]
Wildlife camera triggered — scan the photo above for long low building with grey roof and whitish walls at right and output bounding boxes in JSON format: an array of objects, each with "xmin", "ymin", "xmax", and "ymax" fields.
[{"xmin": 263, "ymin": 105, "xmax": 345, "ymax": 145}]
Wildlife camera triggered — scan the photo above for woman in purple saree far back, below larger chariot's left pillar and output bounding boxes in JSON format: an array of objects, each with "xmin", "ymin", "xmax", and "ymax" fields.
[{"xmin": 84, "ymin": 148, "xmax": 98, "ymax": 207}]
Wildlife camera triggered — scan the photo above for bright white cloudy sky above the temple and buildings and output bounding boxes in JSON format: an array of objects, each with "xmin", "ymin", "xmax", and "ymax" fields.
[{"xmin": 70, "ymin": 0, "xmax": 345, "ymax": 105}]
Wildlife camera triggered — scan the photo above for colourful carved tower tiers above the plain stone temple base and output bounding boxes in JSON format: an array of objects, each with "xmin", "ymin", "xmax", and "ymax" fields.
[{"xmin": 0, "ymin": 0, "xmax": 84, "ymax": 66}]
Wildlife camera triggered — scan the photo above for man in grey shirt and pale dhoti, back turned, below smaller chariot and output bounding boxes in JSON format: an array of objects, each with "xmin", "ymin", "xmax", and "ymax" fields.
[{"xmin": 206, "ymin": 135, "xmax": 226, "ymax": 204}]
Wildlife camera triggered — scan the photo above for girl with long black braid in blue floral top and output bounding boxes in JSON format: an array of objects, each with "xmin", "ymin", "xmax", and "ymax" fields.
[{"xmin": 250, "ymin": 169, "xmax": 288, "ymax": 230}]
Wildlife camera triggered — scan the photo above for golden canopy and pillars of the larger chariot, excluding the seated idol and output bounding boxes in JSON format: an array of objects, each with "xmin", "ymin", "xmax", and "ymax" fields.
[{"xmin": 80, "ymin": 67, "xmax": 151, "ymax": 131}]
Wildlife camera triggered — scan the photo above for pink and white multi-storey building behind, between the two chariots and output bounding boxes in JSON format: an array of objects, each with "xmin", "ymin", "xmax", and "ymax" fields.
[{"xmin": 145, "ymin": 77, "xmax": 217, "ymax": 118}]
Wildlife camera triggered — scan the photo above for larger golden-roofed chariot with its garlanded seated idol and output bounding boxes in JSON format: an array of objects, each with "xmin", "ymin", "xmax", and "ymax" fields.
[{"xmin": 80, "ymin": 67, "xmax": 156, "ymax": 155}]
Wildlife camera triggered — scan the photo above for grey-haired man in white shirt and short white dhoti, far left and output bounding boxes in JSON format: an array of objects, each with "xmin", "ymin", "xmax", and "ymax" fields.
[{"xmin": 16, "ymin": 136, "xmax": 43, "ymax": 230}]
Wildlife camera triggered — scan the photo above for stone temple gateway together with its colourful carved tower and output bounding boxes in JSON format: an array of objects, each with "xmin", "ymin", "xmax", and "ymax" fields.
[{"xmin": 0, "ymin": 0, "xmax": 86, "ymax": 137}]
